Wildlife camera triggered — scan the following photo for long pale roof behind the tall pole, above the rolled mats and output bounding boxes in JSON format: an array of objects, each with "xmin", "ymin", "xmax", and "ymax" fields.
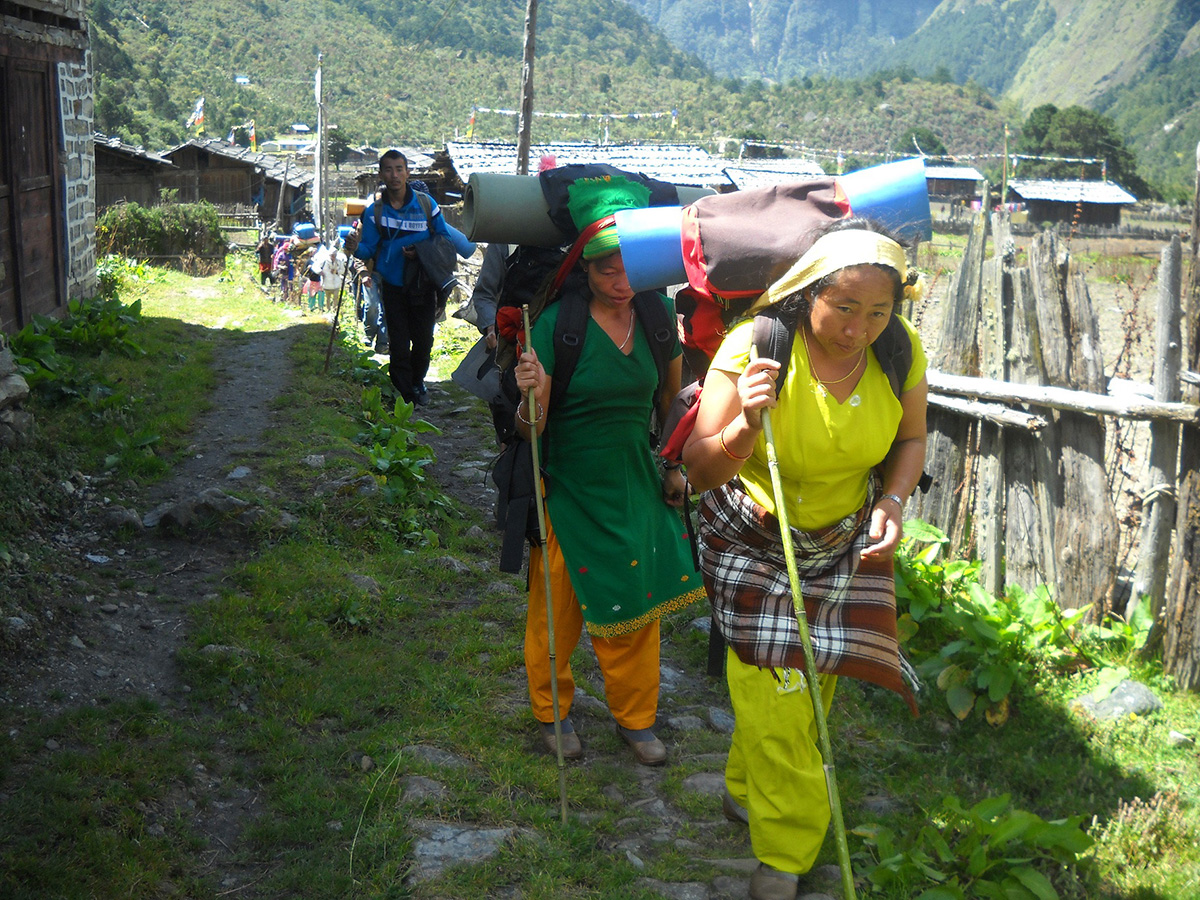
[{"xmin": 446, "ymin": 142, "xmax": 730, "ymax": 187}]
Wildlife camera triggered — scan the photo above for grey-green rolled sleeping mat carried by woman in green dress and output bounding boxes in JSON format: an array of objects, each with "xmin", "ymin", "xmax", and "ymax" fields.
[{"xmin": 462, "ymin": 172, "xmax": 715, "ymax": 247}]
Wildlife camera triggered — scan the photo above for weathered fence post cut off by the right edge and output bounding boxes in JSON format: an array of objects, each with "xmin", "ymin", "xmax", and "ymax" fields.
[{"xmin": 1163, "ymin": 144, "xmax": 1200, "ymax": 690}]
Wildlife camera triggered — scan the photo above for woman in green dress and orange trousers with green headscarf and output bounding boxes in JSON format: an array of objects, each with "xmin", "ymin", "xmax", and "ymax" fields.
[{"xmin": 516, "ymin": 182, "xmax": 704, "ymax": 766}]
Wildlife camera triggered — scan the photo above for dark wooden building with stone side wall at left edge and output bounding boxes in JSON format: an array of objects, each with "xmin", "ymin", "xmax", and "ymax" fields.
[{"xmin": 0, "ymin": 0, "xmax": 97, "ymax": 332}]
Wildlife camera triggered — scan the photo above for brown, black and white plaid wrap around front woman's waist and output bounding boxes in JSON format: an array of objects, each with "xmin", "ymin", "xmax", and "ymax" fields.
[{"xmin": 700, "ymin": 479, "xmax": 917, "ymax": 713}]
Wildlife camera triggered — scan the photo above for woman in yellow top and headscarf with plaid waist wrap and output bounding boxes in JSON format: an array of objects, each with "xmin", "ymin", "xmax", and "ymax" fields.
[{"xmin": 683, "ymin": 218, "xmax": 928, "ymax": 900}]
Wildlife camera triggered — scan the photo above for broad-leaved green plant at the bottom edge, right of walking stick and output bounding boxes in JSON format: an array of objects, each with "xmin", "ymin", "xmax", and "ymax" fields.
[{"xmin": 854, "ymin": 794, "xmax": 1093, "ymax": 900}]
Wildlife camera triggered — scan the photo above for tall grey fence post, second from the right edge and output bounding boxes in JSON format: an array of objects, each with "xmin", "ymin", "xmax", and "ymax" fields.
[{"xmin": 1124, "ymin": 235, "xmax": 1183, "ymax": 620}]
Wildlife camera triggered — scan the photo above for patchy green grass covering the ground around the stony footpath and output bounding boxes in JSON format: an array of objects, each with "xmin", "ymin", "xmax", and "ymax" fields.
[{"xmin": 0, "ymin": 248, "xmax": 1200, "ymax": 900}]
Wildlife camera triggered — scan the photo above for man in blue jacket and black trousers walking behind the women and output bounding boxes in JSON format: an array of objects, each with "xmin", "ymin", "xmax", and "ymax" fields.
[{"xmin": 346, "ymin": 149, "xmax": 456, "ymax": 406}]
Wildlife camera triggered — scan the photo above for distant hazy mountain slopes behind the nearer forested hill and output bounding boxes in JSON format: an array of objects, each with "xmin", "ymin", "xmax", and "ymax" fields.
[{"xmin": 624, "ymin": 0, "xmax": 1200, "ymax": 196}]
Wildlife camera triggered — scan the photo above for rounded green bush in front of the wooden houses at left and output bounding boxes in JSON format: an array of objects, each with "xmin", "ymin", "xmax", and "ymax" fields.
[{"xmin": 96, "ymin": 203, "xmax": 226, "ymax": 259}]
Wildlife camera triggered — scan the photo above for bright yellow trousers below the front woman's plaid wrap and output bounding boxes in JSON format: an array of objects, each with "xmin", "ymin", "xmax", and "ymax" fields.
[{"xmin": 725, "ymin": 649, "xmax": 838, "ymax": 874}]
